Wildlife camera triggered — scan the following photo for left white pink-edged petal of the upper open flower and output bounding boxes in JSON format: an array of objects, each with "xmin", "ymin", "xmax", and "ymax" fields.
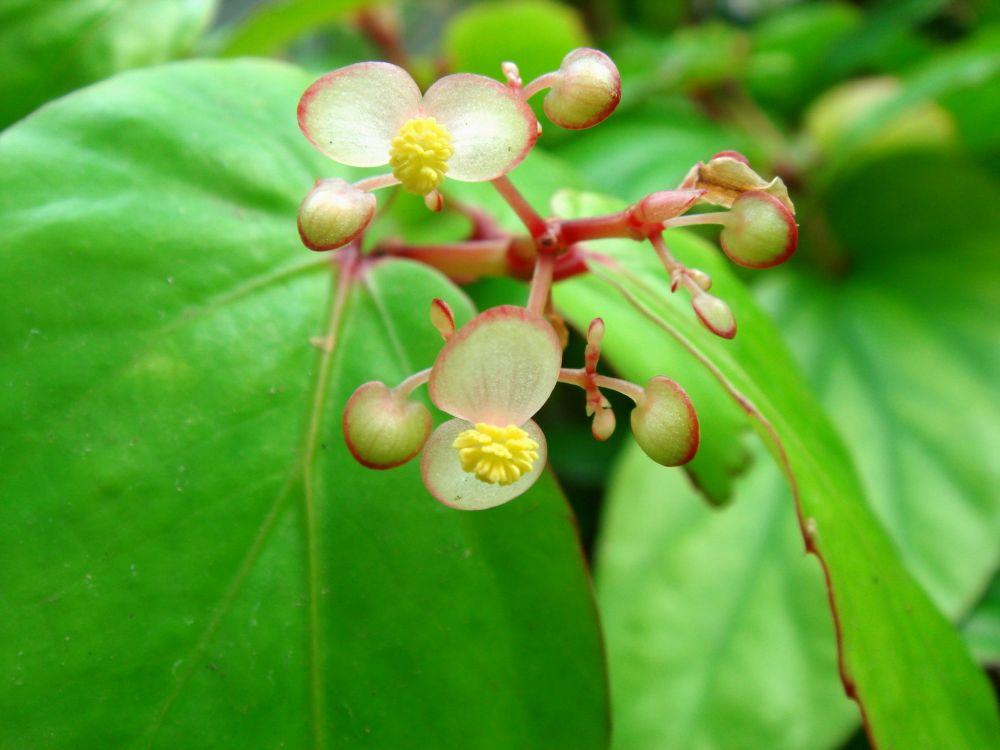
[{"xmin": 299, "ymin": 62, "xmax": 420, "ymax": 167}]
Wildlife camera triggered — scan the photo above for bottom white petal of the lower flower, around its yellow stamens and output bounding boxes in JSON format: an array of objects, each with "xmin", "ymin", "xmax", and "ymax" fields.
[{"xmin": 420, "ymin": 419, "xmax": 546, "ymax": 510}]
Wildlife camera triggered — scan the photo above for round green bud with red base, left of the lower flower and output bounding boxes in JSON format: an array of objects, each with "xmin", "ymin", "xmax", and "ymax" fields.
[{"xmin": 343, "ymin": 381, "xmax": 432, "ymax": 469}]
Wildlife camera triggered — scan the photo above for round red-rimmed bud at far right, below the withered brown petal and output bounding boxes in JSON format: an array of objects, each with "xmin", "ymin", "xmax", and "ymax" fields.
[{"xmin": 719, "ymin": 190, "xmax": 799, "ymax": 268}]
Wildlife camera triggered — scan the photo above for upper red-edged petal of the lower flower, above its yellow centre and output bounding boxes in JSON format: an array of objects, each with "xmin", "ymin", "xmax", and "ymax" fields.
[{"xmin": 428, "ymin": 305, "xmax": 562, "ymax": 427}]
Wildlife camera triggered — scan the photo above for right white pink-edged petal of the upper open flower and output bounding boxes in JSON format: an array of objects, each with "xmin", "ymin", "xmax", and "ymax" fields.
[{"xmin": 423, "ymin": 73, "xmax": 538, "ymax": 182}]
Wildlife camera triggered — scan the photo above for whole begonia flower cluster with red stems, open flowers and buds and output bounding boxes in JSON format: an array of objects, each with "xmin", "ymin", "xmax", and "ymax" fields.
[{"xmin": 298, "ymin": 49, "xmax": 798, "ymax": 510}]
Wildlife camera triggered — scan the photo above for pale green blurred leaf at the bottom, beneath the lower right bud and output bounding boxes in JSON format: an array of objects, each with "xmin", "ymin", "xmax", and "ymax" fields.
[{"xmin": 597, "ymin": 444, "xmax": 857, "ymax": 750}]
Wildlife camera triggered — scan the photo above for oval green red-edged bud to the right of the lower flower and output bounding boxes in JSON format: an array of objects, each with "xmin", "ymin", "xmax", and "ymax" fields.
[{"xmin": 632, "ymin": 375, "xmax": 699, "ymax": 466}]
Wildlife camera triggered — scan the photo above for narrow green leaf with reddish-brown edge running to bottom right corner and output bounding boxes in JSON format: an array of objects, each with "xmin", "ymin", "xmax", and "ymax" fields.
[{"xmin": 556, "ymin": 191, "xmax": 1000, "ymax": 748}]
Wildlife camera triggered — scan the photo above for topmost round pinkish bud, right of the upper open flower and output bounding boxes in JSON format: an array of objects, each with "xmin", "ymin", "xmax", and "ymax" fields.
[{"xmin": 542, "ymin": 47, "xmax": 622, "ymax": 130}]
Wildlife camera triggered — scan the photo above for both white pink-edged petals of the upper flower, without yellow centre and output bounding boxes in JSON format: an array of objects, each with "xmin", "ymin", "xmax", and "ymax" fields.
[{"xmin": 298, "ymin": 62, "xmax": 538, "ymax": 182}]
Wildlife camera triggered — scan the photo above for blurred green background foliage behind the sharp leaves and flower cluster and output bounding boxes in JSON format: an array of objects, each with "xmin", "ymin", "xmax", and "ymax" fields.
[{"xmin": 0, "ymin": 0, "xmax": 1000, "ymax": 750}]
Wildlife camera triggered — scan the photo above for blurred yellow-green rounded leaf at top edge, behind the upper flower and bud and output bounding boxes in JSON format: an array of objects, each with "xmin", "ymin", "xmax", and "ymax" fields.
[{"xmin": 443, "ymin": 0, "xmax": 590, "ymax": 84}]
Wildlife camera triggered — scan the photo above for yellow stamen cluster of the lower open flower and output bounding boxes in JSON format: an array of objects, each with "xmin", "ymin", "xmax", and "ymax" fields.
[{"xmin": 451, "ymin": 422, "xmax": 538, "ymax": 484}]
